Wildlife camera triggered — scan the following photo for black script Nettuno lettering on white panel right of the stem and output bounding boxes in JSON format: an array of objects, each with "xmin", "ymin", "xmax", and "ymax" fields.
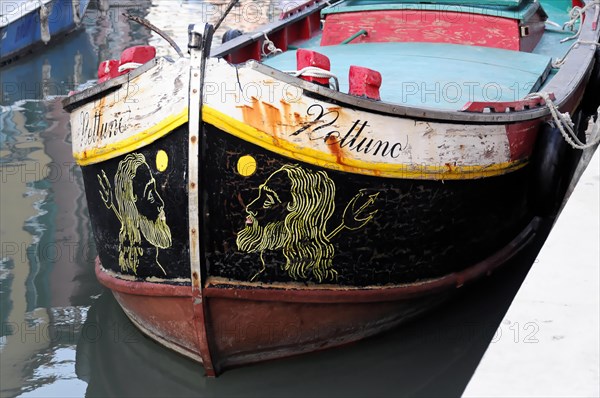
[{"xmin": 291, "ymin": 104, "xmax": 408, "ymax": 159}]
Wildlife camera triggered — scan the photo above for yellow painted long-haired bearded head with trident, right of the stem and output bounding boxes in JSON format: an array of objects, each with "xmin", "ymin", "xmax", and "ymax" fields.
[{"xmin": 236, "ymin": 165, "xmax": 379, "ymax": 282}]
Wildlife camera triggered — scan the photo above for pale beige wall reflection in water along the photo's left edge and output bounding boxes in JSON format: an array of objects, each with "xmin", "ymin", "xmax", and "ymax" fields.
[{"xmin": 0, "ymin": 102, "xmax": 49, "ymax": 393}]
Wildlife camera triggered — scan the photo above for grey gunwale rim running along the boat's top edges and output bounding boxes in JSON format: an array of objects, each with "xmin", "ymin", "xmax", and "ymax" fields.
[{"xmin": 58, "ymin": 3, "xmax": 600, "ymax": 124}]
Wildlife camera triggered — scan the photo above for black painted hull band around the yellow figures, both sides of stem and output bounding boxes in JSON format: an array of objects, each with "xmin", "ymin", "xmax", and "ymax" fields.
[{"xmin": 83, "ymin": 124, "xmax": 533, "ymax": 287}]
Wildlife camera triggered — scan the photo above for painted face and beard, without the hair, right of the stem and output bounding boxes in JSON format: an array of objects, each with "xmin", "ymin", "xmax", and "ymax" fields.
[{"xmin": 236, "ymin": 171, "xmax": 292, "ymax": 253}]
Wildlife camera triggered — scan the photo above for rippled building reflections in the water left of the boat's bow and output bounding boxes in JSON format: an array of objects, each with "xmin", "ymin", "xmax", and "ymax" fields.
[{"xmin": 0, "ymin": 99, "xmax": 99, "ymax": 395}]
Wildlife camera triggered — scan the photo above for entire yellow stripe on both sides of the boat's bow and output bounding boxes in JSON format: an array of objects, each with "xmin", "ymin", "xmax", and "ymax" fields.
[{"xmin": 74, "ymin": 105, "xmax": 527, "ymax": 180}]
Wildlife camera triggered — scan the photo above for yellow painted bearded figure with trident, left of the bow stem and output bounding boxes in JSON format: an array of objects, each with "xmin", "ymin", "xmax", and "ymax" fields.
[{"xmin": 97, "ymin": 151, "xmax": 171, "ymax": 275}]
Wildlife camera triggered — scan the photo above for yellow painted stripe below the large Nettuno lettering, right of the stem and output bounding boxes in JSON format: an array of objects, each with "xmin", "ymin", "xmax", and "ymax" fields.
[{"xmin": 202, "ymin": 106, "xmax": 527, "ymax": 180}]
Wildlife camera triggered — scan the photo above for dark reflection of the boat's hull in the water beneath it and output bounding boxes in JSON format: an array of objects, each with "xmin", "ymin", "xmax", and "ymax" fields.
[{"xmin": 76, "ymin": 222, "xmax": 551, "ymax": 397}]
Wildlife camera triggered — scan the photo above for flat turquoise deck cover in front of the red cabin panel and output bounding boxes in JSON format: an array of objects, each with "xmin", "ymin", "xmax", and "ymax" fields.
[{"xmin": 264, "ymin": 43, "xmax": 551, "ymax": 110}]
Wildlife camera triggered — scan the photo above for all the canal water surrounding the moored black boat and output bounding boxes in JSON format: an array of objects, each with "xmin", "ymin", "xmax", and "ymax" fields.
[{"xmin": 0, "ymin": 0, "xmax": 592, "ymax": 397}]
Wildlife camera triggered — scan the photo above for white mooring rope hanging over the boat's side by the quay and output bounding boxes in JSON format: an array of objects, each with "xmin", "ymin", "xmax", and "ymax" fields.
[{"xmin": 525, "ymin": 92, "xmax": 600, "ymax": 150}]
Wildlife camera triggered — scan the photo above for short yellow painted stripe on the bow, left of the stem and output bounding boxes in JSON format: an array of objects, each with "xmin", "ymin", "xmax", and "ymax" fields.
[{"xmin": 73, "ymin": 108, "xmax": 188, "ymax": 166}]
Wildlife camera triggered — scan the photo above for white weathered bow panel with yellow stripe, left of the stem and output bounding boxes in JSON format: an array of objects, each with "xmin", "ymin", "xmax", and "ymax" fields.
[{"xmin": 70, "ymin": 58, "xmax": 189, "ymax": 165}]
